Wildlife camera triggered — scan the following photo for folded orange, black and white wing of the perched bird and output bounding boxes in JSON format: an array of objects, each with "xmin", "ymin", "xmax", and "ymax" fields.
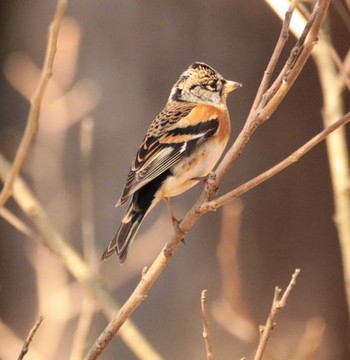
[{"xmin": 116, "ymin": 103, "xmax": 219, "ymax": 206}]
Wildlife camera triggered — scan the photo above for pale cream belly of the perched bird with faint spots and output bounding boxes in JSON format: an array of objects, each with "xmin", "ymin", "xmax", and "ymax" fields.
[{"xmin": 162, "ymin": 139, "xmax": 226, "ymax": 197}]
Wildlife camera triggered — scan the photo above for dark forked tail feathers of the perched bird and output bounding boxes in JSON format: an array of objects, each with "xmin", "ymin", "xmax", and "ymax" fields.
[{"xmin": 101, "ymin": 199, "xmax": 148, "ymax": 263}]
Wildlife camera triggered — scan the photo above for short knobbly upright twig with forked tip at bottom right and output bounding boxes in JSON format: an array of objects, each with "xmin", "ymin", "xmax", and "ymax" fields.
[{"xmin": 254, "ymin": 269, "xmax": 300, "ymax": 360}]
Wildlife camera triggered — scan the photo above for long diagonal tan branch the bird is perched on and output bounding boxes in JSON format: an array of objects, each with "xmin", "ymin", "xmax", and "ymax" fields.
[{"xmin": 84, "ymin": 0, "xmax": 330, "ymax": 360}]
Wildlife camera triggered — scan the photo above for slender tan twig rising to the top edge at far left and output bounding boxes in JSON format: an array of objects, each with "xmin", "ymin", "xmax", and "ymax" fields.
[{"xmin": 0, "ymin": 0, "xmax": 67, "ymax": 208}]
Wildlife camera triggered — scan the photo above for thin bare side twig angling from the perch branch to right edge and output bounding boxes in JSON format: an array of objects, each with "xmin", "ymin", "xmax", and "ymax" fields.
[{"xmin": 200, "ymin": 112, "xmax": 350, "ymax": 212}]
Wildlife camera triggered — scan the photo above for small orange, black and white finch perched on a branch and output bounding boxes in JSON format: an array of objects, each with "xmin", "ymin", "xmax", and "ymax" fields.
[{"xmin": 101, "ymin": 62, "xmax": 242, "ymax": 263}]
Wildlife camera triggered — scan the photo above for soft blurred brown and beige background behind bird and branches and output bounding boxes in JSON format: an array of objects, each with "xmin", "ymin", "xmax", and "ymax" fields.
[{"xmin": 0, "ymin": 0, "xmax": 350, "ymax": 360}]
